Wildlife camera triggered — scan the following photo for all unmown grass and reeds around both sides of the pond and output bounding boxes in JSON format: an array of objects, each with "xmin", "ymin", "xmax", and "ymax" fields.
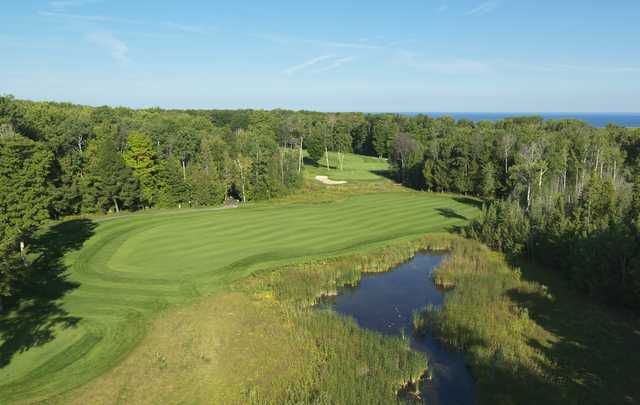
[{"xmin": 63, "ymin": 227, "xmax": 640, "ymax": 404}]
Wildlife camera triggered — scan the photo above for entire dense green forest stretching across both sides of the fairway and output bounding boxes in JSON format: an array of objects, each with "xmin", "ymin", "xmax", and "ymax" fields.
[{"xmin": 0, "ymin": 96, "xmax": 640, "ymax": 309}]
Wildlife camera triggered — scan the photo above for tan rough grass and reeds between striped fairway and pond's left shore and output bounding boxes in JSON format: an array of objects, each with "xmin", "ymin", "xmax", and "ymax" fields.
[{"xmin": 61, "ymin": 234, "xmax": 457, "ymax": 404}]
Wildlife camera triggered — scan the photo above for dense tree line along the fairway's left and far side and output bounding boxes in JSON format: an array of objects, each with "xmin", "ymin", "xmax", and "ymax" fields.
[{"xmin": 0, "ymin": 96, "xmax": 432, "ymax": 309}]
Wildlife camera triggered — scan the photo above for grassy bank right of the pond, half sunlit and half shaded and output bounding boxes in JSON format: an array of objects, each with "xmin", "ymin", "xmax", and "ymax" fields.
[{"xmin": 414, "ymin": 240, "xmax": 640, "ymax": 404}]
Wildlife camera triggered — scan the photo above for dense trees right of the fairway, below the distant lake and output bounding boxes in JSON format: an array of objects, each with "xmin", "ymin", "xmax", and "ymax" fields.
[{"xmin": 374, "ymin": 113, "xmax": 640, "ymax": 311}]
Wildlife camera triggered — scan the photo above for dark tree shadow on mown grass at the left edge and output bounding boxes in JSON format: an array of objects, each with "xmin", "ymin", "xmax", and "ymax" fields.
[{"xmin": 0, "ymin": 219, "xmax": 95, "ymax": 368}]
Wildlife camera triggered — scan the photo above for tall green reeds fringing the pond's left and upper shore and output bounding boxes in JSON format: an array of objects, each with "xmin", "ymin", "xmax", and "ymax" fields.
[{"xmin": 236, "ymin": 235, "xmax": 457, "ymax": 404}]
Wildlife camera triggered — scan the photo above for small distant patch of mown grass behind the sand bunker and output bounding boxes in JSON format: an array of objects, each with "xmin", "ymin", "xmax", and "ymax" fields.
[{"xmin": 305, "ymin": 152, "xmax": 391, "ymax": 182}]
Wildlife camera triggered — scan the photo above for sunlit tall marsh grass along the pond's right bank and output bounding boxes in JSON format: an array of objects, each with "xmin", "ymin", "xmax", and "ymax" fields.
[{"xmin": 413, "ymin": 239, "xmax": 555, "ymax": 404}]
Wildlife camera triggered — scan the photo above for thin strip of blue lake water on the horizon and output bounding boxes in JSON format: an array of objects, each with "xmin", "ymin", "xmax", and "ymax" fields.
[{"xmin": 401, "ymin": 112, "xmax": 640, "ymax": 128}]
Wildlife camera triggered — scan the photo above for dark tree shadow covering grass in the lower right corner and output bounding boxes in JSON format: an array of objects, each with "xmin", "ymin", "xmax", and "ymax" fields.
[{"xmin": 507, "ymin": 260, "xmax": 640, "ymax": 404}]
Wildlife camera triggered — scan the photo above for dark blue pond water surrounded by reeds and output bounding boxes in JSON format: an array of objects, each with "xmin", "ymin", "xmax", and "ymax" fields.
[{"xmin": 324, "ymin": 253, "xmax": 476, "ymax": 405}]
